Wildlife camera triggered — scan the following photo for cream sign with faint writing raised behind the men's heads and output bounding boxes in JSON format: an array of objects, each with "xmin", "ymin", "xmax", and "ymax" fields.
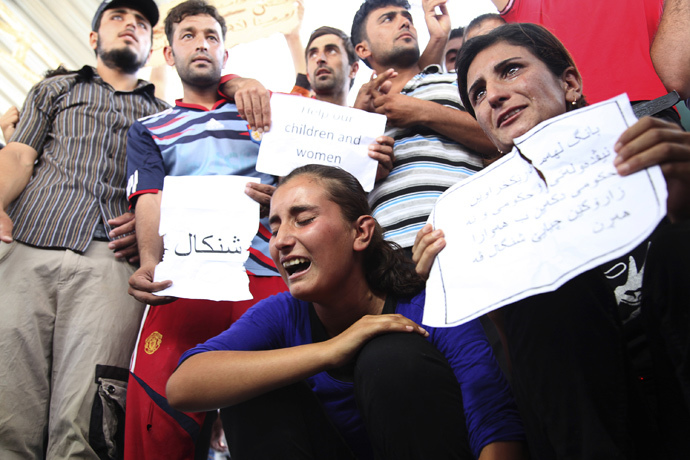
[{"xmin": 148, "ymin": 0, "xmax": 299, "ymax": 67}]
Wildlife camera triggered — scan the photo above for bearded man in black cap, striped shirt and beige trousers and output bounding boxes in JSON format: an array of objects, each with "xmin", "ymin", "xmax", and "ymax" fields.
[{"xmin": 0, "ymin": 0, "xmax": 167, "ymax": 459}]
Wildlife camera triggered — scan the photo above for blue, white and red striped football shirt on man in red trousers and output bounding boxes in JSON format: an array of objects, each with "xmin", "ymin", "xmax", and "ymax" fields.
[{"xmin": 127, "ymin": 101, "xmax": 280, "ymax": 276}]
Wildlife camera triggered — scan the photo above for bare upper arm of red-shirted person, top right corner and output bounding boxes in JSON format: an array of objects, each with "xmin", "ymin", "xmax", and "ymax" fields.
[{"xmin": 650, "ymin": 0, "xmax": 690, "ymax": 99}]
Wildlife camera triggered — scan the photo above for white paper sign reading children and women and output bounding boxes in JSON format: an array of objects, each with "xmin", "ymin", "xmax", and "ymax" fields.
[{"xmin": 256, "ymin": 94, "xmax": 386, "ymax": 192}]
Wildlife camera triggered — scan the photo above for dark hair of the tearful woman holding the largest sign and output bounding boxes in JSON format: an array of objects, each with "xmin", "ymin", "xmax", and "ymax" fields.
[{"xmin": 455, "ymin": 23, "xmax": 587, "ymax": 118}]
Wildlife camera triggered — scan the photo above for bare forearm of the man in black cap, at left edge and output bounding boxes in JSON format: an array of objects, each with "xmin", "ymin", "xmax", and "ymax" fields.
[{"xmin": 0, "ymin": 142, "xmax": 38, "ymax": 243}]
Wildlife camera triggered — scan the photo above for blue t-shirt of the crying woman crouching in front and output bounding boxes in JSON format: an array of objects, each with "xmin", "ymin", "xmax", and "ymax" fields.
[{"xmin": 180, "ymin": 292, "xmax": 525, "ymax": 459}]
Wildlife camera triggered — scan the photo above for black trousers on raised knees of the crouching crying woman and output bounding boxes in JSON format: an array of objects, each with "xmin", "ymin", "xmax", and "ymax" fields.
[{"xmin": 221, "ymin": 333, "xmax": 473, "ymax": 460}]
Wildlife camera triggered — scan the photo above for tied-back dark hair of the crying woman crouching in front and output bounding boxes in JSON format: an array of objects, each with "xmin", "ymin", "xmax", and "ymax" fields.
[{"xmin": 278, "ymin": 164, "xmax": 425, "ymax": 298}]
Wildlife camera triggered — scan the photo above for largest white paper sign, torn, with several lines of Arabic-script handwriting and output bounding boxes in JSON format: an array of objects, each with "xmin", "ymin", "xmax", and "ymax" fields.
[{"xmin": 424, "ymin": 95, "xmax": 667, "ymax": 327}]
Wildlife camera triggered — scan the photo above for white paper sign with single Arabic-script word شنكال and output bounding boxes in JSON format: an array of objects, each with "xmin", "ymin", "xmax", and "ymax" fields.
[{"xmin": 154, "ymin": 176, "xmax": 259, "ymax": 301}]
